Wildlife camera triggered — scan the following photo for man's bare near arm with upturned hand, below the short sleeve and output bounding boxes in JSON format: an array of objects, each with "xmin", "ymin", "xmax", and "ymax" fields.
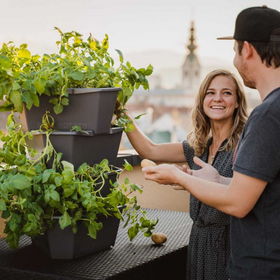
[{"xmin": 143, "ymin": 164, "xmax": 267, "ymax": 218}]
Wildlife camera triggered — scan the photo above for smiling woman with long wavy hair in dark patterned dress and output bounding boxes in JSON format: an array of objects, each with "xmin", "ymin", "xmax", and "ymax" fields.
[{"xmin": 121, "ymin": 70, "xmax": 247, "ymax": 280}]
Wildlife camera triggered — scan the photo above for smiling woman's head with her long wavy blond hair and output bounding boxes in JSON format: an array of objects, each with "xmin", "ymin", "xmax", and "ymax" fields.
[{"xmin": 188, "ymin": 70, "xmax": 247, "ymax": 162}]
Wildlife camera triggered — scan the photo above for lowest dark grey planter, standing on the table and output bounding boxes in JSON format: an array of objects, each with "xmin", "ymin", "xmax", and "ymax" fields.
[{"xmin": 32, "ymin": 207, "xmax": 120, "ymax": 259}]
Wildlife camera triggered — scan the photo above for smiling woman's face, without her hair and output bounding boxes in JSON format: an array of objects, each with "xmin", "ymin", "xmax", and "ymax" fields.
[{"xmin": 203, "ymin": 75, "xmax": 238, "ymax": 121}]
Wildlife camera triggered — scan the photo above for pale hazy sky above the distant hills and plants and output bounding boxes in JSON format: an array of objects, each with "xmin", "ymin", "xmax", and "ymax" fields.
[{"xmin": 0, "ymin": 0, "xmax": 280, "ymax": 60}]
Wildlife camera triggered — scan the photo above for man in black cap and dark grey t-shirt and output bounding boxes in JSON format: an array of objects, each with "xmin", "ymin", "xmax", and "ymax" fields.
[{"xmin": 143, "ymin": 6, "xmax": 280, "ymax": 280}]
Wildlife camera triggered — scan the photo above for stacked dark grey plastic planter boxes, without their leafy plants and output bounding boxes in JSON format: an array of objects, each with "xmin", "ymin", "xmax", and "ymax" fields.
[{"xmin": 21, "ymin": 88, "xmax": 124, "ymax": 259}]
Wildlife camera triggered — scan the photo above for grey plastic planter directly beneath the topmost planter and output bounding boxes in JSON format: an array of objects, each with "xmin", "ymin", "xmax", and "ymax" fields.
[{"xmin": 27, "ymin": 127, "xmax": 124, "ymax": 169}]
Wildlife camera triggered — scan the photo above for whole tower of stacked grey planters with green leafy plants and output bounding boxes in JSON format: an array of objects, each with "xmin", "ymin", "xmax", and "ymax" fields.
[{"xmin": 0, "ymin": 27, "xmax": 157, "ymax": 259}]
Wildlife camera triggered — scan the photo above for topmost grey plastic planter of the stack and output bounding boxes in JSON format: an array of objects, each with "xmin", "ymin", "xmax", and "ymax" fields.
[{"xmin": 20, "ymin": 88, "xmax": 121, "ymax": 134}]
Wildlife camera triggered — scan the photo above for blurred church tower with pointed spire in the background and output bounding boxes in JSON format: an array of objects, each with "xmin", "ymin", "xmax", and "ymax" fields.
[{"xmin": 182, "ymin": 21, "xmax": 201, "ymax": 91}]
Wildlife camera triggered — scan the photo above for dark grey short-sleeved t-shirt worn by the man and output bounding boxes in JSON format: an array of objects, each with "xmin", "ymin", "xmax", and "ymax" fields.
[{"xmin": 229, "ymin": 88, "xmax": 280, "ymax": 280}]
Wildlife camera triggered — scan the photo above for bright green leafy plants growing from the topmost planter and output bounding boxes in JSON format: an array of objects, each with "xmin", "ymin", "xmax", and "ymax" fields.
[{"xmin": 0, "ymin": 27, "xmax": 153, "ymax": 131}]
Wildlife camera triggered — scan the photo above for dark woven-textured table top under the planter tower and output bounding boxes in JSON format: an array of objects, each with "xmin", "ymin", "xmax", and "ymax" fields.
[{"xmin": 0, "ymin": 209, "xmax": 192, "ymax": 280}]
